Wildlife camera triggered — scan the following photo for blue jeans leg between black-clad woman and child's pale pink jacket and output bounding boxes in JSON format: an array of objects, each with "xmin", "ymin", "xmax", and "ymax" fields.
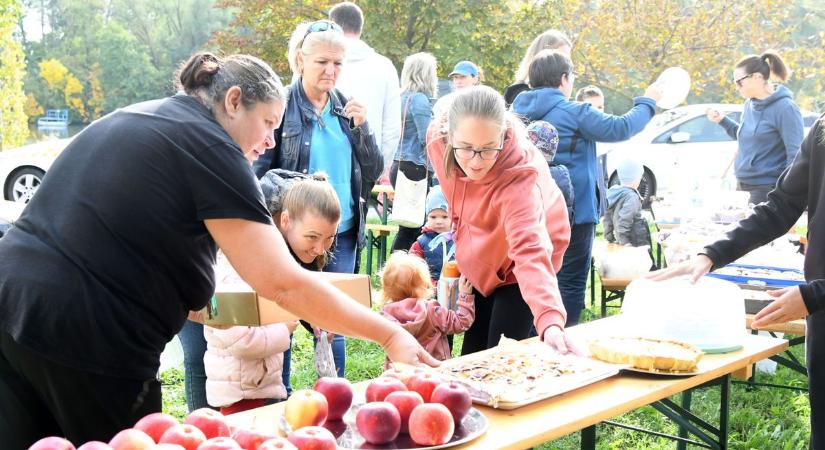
[{"xmin": 178, "ymin": 320, "xmax": 211, "ymax": 412}]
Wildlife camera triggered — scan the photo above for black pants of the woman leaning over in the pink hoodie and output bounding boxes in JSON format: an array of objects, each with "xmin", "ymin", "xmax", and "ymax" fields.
[{"xmin": 461, "ymin": 284, "xmax": 533, "ymax": 355}]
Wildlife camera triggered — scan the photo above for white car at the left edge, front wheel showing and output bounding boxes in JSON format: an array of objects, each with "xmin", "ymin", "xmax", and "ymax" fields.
[{"xmin": 0, "ymin": 138, "xmax": 71, "ymax": 203}]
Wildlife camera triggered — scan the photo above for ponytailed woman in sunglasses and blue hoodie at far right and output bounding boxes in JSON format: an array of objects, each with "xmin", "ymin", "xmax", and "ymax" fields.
[{"xmin": 707, "ymin": 52, "xmax": 804, "ymax": 204}]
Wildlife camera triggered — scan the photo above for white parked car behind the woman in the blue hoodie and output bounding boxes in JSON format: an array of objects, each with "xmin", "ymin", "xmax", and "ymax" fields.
[{"xmin": 598, "ymin": 103, "xmax": 819, "ymax": 204}]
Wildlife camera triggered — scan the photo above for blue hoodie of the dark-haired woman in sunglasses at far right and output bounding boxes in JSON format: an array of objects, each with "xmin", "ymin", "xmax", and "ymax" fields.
[{"xmin": 719, "ymin": 84, "xmax": 805, "ymax": 186}]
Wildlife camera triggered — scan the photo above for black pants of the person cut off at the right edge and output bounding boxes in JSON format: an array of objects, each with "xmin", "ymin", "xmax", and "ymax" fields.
[{"xmin": 805, "ymin": 311, "xmax": 825, "ymax": 450}]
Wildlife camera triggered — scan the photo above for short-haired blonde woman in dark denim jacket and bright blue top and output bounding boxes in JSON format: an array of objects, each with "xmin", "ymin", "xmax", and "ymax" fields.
[{"xmin": 255, "ymin": 20, "xmax": 384, "ymax": 376}]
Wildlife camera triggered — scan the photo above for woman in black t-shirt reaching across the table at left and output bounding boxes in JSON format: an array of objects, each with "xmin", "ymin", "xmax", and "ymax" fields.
[{"xmin": 0, "ymin": 53, "xmax": 435, "ymax": 450}]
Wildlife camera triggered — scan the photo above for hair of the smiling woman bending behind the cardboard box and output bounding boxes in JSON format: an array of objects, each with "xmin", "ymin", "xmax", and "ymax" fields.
[{"xmin": 269, "ymin": 172, "xmax": 341, "ymax": 270}]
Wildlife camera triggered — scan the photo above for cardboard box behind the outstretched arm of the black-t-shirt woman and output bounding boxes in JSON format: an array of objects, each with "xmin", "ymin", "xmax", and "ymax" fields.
[{"xmin": 189, "ymin": 272, "xmax": 372, "ymax": 326}]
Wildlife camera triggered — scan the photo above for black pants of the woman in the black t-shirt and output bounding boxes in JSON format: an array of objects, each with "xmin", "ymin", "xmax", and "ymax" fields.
[{"xmin": 0, "ymin": 332, "xmax": 161, "ymax": 450}]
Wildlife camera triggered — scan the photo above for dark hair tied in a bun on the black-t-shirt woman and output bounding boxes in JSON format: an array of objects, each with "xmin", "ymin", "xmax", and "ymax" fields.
[{"xmin": 177, "ymin": 52, "xmax": 286, "ymax": 109}]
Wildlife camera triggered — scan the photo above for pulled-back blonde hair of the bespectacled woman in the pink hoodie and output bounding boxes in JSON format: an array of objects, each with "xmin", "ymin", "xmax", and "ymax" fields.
[{"xmin": 430, "ymin": 86, "xmax": 527, "ymax": 178}]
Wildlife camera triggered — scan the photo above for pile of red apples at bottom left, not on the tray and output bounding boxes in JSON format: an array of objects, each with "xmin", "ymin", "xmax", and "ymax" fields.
[{"xmin": 29, "ymin": 408, "xmax": 308, "ymax": 450}]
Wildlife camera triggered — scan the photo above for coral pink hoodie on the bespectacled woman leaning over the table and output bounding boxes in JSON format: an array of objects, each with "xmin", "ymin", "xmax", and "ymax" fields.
[{"xmin": 427, "ymin": 122, "xmax": 570, "ymax": 336}]
